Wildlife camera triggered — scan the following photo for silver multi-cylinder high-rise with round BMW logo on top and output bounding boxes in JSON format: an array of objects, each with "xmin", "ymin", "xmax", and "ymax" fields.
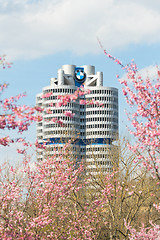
[{"xmin": 36, "ymin": 65, "xmax": 118, "ymax": 174}]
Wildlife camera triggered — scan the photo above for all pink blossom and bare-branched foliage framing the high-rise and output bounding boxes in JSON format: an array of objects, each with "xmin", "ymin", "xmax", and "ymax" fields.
[{"xmin": 0, "ymin": 54, "xmax": 160, "ymax": 240}]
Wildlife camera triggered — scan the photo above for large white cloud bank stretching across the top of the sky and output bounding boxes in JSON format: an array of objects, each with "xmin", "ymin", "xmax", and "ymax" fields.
[{"xmin": 0, "ymin": 0, "xmax": 160, "ymax": 59}]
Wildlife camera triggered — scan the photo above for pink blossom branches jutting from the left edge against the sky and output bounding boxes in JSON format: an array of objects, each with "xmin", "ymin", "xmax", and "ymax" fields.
[{"xmin": 0, "ymin": 55, "xmax": 41, "ymax": 146}]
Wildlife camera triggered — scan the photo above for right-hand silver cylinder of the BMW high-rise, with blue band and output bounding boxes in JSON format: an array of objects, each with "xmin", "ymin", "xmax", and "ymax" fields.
[{"xmin": 82, "ymin": 87, "xmax": 118, "ymax": 174}]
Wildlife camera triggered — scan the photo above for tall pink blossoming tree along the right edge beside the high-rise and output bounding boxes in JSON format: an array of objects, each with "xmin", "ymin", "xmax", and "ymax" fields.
[{"xmin": 98, "ymin": 39, "xmax": 160, "ymax": 240}]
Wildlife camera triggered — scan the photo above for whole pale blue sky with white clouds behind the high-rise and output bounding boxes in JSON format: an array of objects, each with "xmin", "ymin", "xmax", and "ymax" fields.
[{"xmin": 0, "ymin": 0, "xmax": 160, "ymax": 163}]
